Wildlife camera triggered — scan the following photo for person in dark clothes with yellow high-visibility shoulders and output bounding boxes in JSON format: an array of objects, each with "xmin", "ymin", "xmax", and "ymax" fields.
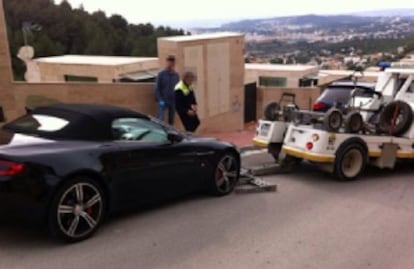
[{"xmin": 175, "ymin": 72, "xmax": 200, "ymax": 132}]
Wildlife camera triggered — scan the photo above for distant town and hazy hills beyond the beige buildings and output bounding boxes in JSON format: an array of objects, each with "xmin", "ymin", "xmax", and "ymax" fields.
[{"xmin": 192, "ymin": 10, "xmax": 414, "ymax": 69}]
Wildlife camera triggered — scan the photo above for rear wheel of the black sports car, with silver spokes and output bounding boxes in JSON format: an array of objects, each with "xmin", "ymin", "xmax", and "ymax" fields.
[{"xmin": 48, "ymin": 177, "xmax": 106, "ymax": 243}]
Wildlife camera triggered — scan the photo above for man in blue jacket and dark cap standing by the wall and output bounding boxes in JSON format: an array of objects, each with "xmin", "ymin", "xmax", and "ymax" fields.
[{"xmin": 155, "ymin": 56, "xmax": 180, "ymax": 125}]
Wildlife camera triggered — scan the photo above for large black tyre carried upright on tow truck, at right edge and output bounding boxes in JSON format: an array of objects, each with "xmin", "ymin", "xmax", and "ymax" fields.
[{"xmin": 379, "ymin": 101, "xmax": 414, "ymax": 136}]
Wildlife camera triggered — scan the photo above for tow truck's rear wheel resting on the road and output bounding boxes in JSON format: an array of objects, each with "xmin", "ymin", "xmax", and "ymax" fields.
[{"xmin": 334, "ymin": 141, "xmax": 368, "ymax": 181}]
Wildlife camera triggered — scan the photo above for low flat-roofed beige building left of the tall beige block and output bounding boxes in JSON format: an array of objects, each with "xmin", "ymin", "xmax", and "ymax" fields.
[{"xmin": 25, "ymin": 55, "xmax": 159, "ymax": 83}]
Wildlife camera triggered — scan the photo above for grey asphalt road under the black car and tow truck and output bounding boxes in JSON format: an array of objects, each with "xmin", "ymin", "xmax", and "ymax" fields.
[{"xmin": 0, "ymin": 153, "xmax": 414, "ymax": 269}]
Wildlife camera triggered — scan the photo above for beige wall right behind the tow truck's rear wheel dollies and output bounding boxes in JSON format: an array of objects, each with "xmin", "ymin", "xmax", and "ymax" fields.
[{"xmin": 257, "ymin": 87, "xmax": 321, "ymax": 119}]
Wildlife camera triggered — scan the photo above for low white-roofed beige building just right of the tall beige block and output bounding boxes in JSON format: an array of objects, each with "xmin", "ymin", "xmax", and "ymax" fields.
[{"xmin": 244, "ymin": 64, "xmax": 319, "ymax": 88}]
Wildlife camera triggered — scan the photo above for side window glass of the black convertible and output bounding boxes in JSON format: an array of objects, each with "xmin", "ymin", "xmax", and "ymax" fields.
[{"xmin": 112, "ymin": 118, "xmax": 168, "ymax": 142}]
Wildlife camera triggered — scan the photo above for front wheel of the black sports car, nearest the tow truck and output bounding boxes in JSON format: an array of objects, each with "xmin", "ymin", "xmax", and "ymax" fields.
[{"xmin": 209, "ymin": 152, "xmax": 240, "ymax": 196}]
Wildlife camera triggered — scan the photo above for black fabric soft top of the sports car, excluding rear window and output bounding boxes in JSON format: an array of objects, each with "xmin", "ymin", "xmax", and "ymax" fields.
[{"xmin": 4, "ymin": 104, "xmax": 148, "ymax": 140}]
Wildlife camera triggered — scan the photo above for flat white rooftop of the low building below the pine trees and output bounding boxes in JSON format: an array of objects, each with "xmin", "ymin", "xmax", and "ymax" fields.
[{"xmin": 34, "ymin": 55, "xmax": 157, "ymax": 66}]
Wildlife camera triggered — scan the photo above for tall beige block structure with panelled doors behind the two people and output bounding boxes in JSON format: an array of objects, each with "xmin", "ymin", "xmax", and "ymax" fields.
[{"xmin": 158, "ymin": 33, "xmax": 244, "ymax": 131}]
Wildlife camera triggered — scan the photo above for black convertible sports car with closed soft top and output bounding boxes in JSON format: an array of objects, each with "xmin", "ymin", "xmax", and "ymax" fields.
[{"xmin": 0, "ymin": 104, "xmax": 240, "ymax": 242}]
